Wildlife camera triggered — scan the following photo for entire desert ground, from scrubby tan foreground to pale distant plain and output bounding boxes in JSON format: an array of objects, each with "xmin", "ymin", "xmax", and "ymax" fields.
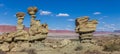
[{"xmin": 0, "ymin": 33, "xmax": 120, "ymax": 54}]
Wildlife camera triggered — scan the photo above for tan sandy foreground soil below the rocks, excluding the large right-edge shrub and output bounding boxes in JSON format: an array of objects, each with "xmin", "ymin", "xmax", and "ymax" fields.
[{"xmin": 0, "ymin": 36, "xmax": 120, "ymax": 54}]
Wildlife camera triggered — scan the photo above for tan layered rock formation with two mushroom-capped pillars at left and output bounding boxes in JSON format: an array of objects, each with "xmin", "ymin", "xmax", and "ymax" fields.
[{"xmin": 0, "ymin": 7, "xmax": 48, "ymax": 51}]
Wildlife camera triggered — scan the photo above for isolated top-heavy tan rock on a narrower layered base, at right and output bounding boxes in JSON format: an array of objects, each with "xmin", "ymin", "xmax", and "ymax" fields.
[{"xmin": 75, "ymin": 16, "xmax": 98, "ymax": 42}]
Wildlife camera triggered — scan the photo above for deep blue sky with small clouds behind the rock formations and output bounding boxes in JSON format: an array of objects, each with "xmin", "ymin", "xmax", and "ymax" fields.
[{"xmin": 0, "ymin": 0, "xmax": 120, "ymax": 31}]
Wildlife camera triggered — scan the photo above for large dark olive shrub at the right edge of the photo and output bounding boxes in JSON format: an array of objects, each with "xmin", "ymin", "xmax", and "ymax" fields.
[{"xmin": 103, "ymin": 39, "xmax": 120, "ymax": 52}]
